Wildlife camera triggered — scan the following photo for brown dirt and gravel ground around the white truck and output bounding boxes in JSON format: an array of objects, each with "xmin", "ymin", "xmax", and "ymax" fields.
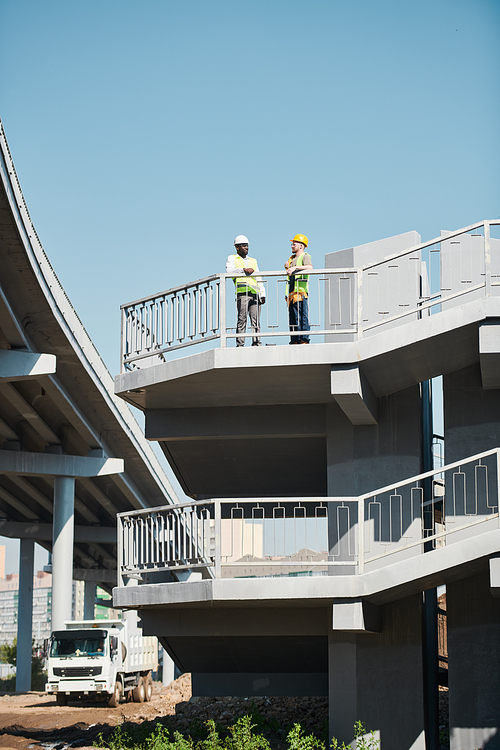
[{"xmin": 0, "ymin": 674, "xmax": 448, "ymax": 750}]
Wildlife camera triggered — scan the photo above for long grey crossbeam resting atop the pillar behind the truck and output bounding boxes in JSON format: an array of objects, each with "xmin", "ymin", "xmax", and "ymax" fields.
[{"xmin": 0, "ymin": 451, "xmax": 125, "ymax": 477}]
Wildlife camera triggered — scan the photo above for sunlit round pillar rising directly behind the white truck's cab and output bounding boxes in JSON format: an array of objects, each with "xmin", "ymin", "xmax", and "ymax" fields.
[{"xmin": 52, "ymin": 477, "xmax": 75, "ymax": 630}]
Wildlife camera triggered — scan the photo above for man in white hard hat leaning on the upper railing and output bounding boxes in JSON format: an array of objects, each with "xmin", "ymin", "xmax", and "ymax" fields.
[{"xmin": 226, "ymin": 234, "xmax": 266, "ymax": 346}]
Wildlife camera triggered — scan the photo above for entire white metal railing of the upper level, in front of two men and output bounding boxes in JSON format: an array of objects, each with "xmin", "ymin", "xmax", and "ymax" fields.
[{"xmin": 121, "ymin": 220, "xmax": 500, "ymax": 371}]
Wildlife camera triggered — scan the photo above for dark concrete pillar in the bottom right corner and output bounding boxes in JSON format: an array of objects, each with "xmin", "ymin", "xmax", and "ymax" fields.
[{"xmin": 446, "ymin": 571, "xmax": 500, "ymax": 750}]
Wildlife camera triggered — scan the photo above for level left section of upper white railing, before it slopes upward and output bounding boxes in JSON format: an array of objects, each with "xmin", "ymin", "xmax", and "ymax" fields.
[{"xmin": 121, "ymin": 269, "xmax": 358, "ymax": 369}]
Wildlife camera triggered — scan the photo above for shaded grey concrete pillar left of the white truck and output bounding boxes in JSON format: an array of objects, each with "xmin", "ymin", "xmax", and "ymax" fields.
[{"xmin": 16, "ymin": 539, "xmax": 35, "ymax": 691}]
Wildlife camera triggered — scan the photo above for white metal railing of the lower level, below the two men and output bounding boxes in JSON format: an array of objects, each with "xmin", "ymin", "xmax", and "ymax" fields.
[{"xmin": 118, "ymin": 449, "xmax": 500, "ymax": 581}]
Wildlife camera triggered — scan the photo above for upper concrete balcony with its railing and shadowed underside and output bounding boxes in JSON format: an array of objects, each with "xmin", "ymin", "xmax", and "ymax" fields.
[{"xmin": 115, "ymin": 221, "xmax": 500, "ymax": 499}]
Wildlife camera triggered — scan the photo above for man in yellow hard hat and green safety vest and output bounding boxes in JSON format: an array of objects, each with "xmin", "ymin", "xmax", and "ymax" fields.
[{"xmin": 285, "ymin": 234, "xmax": 313, "ymax": 344}]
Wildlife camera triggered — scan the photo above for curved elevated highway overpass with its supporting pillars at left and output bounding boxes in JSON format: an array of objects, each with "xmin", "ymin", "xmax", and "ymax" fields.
[{"xmin": 0, "ymin": 119, "xmax": 182, "ymax": 689}]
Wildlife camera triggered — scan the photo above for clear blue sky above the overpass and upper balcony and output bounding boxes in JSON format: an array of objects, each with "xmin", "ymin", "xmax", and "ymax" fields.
[{"xmin": 0, "ymin": 0, "xmax": 500, "ymax": 576}]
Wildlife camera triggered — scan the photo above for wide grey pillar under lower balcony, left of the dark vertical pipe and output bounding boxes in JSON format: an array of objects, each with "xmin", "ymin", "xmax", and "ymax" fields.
[{"xmin": 328, "ymin": 594, "xmax": 425, "ymax": 750}]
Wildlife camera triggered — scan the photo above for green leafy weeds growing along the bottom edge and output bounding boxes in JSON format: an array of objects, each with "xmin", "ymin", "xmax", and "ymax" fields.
[{"xmin": 94, "ymin": 715, "xmax": 380, "ymax": 750}]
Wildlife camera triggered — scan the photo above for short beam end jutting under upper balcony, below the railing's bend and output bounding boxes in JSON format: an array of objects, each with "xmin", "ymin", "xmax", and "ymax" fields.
[{"xmin": 331, "ymin": 364, "xmax": 378, "ymax": 425}]
